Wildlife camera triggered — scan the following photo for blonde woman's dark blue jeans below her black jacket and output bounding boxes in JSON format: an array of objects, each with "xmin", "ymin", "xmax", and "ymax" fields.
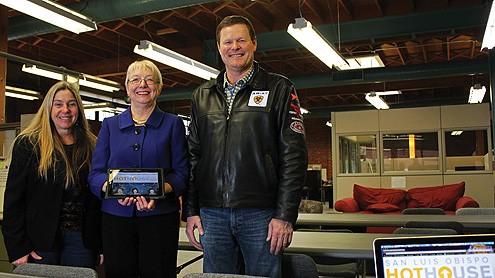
[{"xmin": 30, "ymin": 231, "xmax": 96, "ymax": 268}]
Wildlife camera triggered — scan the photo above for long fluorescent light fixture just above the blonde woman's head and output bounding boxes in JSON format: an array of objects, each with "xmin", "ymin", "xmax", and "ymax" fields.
[{"xmin": 22, "ymin": 64, "xmax": 120, "ymax": 92}]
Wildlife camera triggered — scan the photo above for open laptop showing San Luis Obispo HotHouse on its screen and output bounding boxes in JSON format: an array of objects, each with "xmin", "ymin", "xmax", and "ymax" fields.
[{"xmin": 373, "ymin": 234, "xmax": 495, "ymax": 278}]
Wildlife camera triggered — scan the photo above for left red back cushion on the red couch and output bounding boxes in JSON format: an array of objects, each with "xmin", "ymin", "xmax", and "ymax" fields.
[{"xmin": 353, "ymin": 184, "xmax": 407, "ymax": 210}]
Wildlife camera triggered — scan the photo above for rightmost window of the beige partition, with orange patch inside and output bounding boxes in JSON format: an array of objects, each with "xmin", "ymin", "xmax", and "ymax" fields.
[{"xmin": 444, "ymin": 129, "xmax": 490, "ymax": 171}]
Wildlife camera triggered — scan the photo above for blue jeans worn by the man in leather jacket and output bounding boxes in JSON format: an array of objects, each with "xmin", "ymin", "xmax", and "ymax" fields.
[{"xmin": 200, "ymin": 208, "xmax": 282, "ymax": 277}]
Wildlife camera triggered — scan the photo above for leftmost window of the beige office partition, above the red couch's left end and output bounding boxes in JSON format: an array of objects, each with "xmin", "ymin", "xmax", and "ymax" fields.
[{"xmin": 339, "ymin": 134, "xmax": 377, "ymax": 174}]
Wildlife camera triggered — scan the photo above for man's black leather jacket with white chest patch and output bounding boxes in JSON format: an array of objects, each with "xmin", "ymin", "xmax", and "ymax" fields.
[{"xmin": 183, "ymin": 62, "xmax": 307, "ymax": 223}]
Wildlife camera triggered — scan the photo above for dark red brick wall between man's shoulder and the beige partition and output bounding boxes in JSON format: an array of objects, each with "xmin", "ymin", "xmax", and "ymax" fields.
[{"xmin": 304, "ymin": 118, "xmax": 332, "ymax": 179}]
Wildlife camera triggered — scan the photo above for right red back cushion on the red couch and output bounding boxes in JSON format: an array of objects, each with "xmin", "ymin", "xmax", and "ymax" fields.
[{"xmin": 407, "ymin": 182, "xmax": 465, "ymax": 211}]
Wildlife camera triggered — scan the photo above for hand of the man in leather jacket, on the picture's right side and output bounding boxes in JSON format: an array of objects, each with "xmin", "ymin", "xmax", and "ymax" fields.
[{"xmin": 266, "ymin": 218, "xmax": 293, "ymax": 255}]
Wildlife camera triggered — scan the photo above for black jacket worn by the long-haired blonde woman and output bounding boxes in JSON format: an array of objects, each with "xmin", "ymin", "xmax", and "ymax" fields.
[{"xmin": 2, "ymin": 138, "xmax": 101, "ymax": 262}]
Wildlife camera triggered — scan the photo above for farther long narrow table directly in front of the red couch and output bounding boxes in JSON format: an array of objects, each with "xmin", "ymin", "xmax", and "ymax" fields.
[{"xmin": 296, "ymin": 213, "xmax": 495, "ymax": 229}]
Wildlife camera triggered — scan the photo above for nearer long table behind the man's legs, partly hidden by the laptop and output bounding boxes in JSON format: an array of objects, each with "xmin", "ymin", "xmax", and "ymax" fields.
[{"xmin": 179, "ymin": 228, "xmax": 418, "ymax": 259}]
